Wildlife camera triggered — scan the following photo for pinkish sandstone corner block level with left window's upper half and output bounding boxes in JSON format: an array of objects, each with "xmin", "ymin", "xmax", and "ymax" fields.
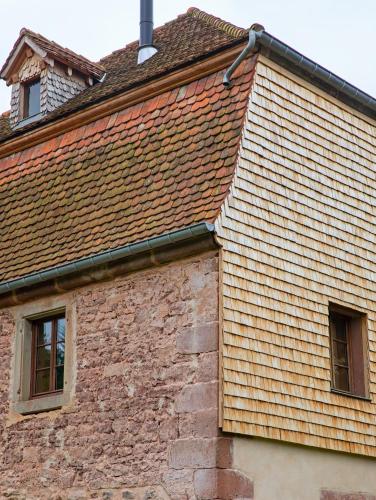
[{"xmin": 176, "ymin": 321, "xmax": 218, "ymax": 354}]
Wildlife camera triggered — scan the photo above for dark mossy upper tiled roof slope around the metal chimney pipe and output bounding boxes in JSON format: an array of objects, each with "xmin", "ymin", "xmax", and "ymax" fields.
[{"xmin": 0, "ymin": 8, "xmax": 248, "ymax": 142}]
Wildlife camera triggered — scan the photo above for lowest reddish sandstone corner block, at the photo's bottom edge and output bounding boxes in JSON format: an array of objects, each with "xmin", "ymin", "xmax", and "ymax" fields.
[{"xmin": 194, "ymin": 469, "xmax": 254, "ymax": 500}]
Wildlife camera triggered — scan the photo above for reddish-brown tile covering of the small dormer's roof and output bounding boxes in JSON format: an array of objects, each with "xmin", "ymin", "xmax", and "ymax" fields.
[{"xmin": 0, "ymin": 28, "xmax": 105, "ymax": 79}]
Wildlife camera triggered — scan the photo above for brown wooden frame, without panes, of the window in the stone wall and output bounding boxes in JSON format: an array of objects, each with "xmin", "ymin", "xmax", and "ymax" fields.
[{"xmin": 30, "ymin": 313, "xmax": 66, "ymax": 399}]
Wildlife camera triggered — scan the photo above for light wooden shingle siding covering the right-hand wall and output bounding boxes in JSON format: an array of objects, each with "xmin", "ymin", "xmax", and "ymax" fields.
[{"xmin": 216, "ymin": 58, "xmax": 376, "ymax": 456}]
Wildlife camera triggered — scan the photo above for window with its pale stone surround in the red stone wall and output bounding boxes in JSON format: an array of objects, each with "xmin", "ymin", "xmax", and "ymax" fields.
[{"xmin": 11, "ymin": 296, "xmax": 76, "ymax": 415}]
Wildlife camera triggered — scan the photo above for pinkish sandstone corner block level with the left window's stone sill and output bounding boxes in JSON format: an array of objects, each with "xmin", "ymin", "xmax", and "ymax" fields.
[{"xmin": 175, "ymin": 382, "xmax": 218, "ymax": 413}]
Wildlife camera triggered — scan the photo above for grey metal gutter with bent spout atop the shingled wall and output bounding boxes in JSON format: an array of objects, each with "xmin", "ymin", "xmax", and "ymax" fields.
[{"xmin": 223, "ymin": 25, "xmax": 376, "ymax": 119}]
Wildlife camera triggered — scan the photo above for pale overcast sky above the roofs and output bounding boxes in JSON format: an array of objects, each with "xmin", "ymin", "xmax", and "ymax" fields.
[{"xmin": 0, "ymin": 0, "xmax": 376, "ymax": 112}]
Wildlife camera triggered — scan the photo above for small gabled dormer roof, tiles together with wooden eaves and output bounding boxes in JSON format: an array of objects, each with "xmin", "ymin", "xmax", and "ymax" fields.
[{"xmin": 0, "ymin": 28, "xmax": 105, "ymax": 83}]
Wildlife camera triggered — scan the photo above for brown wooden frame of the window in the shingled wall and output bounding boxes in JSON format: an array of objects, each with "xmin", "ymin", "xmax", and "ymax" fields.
[{"xmin": 329, "ymin": 303, "xmax": 369, "ymax": 399}]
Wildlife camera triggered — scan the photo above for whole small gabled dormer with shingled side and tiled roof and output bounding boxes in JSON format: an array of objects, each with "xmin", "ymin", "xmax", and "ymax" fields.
[{"xmin": 0, "ymin": 28, "xmax": 105, "ymax": 129}]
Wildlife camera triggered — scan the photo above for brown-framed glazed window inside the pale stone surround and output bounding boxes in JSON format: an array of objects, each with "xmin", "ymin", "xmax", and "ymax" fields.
[{"xmin": 30, "ymin": 315, "xmax": 65, "ymax": 398}]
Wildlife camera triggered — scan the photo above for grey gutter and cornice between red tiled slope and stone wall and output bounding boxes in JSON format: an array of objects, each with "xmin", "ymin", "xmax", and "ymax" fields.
[{"xmin": 0, "ymin": 222, "xmax": 218, "ymax": 307}]
